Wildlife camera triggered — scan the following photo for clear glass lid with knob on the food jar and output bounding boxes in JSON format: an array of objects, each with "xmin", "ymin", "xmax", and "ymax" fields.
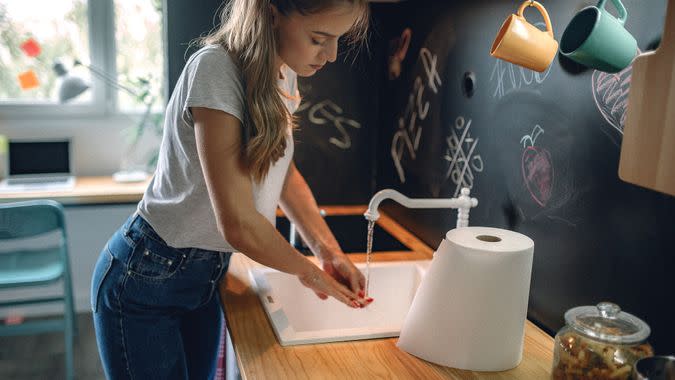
[{"xmin": 565, "ymin": 302, "xmax": 651, "ymax": 344}]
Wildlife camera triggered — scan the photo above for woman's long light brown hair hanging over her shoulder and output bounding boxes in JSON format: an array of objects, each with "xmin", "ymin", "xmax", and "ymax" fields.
[{"xmin": 198, "ymin": 0, "xmax": 370, "ymax": 182}]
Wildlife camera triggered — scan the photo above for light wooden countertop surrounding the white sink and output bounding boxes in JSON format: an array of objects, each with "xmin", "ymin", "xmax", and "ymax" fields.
[{"xmin": 220, "ymin": 206, "xmax": 553, "ymax": 379}]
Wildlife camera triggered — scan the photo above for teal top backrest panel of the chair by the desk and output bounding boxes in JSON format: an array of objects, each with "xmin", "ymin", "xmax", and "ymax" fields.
[{"xmin": 0, "ymin": 200, "xmax": 66, "ymax": 240}]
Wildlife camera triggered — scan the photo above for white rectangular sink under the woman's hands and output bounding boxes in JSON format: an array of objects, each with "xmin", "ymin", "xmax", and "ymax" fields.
[{"xmin": 249, "ymin": 260, "xmax": 431, "ymax": 346}]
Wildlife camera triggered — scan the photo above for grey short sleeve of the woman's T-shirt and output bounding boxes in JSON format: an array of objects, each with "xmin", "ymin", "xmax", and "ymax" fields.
[{"xmin": 182, "ymin": 46, "xmax": 245, "ymax": 125}]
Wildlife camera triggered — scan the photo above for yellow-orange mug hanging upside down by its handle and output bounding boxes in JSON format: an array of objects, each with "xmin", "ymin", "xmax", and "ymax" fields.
[{"xmin": 490, "ymin": 0, "xmax": 558, "ymax": 72}]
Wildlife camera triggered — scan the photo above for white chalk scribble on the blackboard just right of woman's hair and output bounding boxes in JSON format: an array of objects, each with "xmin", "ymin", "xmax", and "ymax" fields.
[{"xmin": 296, "ymin": 99, "xmax": 361, "ymax": 150}]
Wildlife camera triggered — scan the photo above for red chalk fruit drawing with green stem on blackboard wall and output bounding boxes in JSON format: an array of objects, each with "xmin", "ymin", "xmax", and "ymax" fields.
[{"xmin": 520, "ymin": 125, "xmax": 555, "ymax": 207}]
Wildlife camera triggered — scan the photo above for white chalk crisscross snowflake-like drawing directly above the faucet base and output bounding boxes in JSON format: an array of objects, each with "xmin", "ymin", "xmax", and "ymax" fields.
[{"xmin": 443, "ymin": 116, "xmax": 484, "ymax": 197}]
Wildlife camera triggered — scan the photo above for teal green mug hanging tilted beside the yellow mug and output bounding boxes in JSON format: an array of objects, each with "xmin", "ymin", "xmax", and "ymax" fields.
[{"xmin": 560, "ymin": 0, "xmax": 638, "ymax": 73}]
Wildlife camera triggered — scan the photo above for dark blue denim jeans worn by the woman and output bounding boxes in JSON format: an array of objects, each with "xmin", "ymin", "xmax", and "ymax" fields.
[{"xmin": 91, "ymin": 214, "xmax": 231, "ymax": 380}]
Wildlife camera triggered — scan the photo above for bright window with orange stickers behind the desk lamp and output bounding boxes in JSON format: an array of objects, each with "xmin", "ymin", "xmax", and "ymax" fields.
[{"xmin": 0, "ymin": 0, "xmax": 165, "ymax": 115}]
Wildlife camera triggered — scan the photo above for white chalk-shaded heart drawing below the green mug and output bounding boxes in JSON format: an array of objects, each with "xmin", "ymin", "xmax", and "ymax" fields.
[{"xmin": 591, "ymin": 51, "xmax": 640, "ymax": 135}]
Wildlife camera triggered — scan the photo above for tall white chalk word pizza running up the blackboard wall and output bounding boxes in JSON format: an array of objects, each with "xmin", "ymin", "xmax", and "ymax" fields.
[{"xmin": 391, "ymin": 48, "xmax": 443, "ymax": 183}]
